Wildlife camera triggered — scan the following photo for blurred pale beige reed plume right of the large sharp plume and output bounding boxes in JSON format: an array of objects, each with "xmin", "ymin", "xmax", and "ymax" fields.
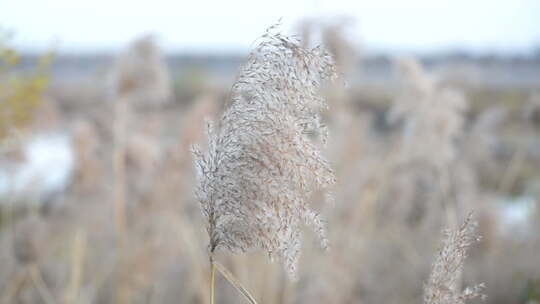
[{"xmin": 388, "ymin": 59, "xmax": 467, "ymax": 168}]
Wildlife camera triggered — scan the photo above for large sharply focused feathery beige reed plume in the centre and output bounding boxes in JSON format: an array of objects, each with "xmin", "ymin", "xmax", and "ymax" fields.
[{"xmin": 192, "ymin": 25, "xmax": 336, "ymax": 278}]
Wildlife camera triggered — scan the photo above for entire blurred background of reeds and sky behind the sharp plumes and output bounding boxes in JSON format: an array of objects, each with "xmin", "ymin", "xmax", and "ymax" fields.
[{"xmin": 0, "ymin": 0, "xmax": 540, "ymax": 304}]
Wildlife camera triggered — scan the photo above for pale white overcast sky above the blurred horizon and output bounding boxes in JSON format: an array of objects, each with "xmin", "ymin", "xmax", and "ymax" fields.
[{"xmin": 0, "ymin": 0, "xmax": 540, "ymax": 53}]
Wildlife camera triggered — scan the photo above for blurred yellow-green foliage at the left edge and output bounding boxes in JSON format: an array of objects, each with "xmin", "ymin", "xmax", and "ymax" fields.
[{"xmin": 0, "ymin": 29, "xmax": 52, "ymax": 139}]
